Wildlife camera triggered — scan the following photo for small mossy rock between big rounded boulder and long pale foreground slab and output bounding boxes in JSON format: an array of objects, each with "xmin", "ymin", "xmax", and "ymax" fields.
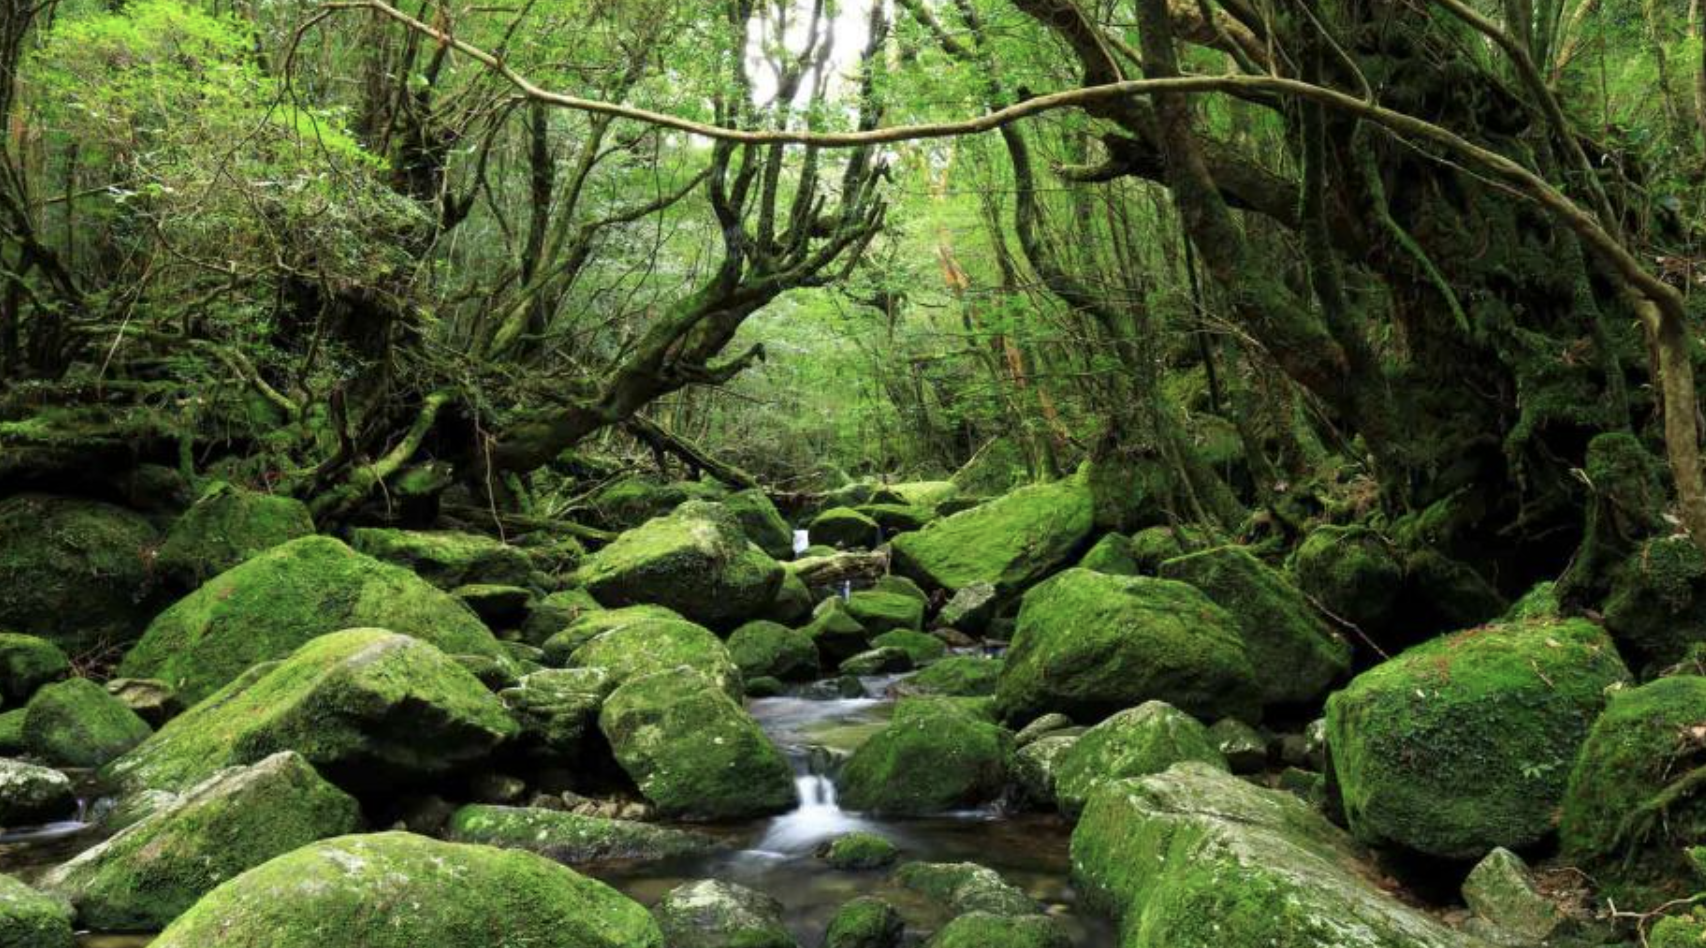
[{"xmin": 1053, "ymin": 701, "xmax": 1230, "ymax": 817}]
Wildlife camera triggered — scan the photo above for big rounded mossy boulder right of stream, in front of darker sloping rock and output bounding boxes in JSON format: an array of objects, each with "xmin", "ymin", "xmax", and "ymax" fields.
[{"xmin": 996, "ymin": 569, "xmax": 1261, "ymax": 721}]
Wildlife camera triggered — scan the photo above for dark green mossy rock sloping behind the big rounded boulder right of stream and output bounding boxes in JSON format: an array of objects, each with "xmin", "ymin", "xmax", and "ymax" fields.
[{"xmin": 1160, "ymin": 546, "xmax": 1351, "ymax": 706}]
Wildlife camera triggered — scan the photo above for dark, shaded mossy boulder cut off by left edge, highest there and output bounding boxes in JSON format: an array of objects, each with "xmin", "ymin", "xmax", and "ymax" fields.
[{"xmin": 0, "ymin": 494, "xmax": 159, "ymax": 655}]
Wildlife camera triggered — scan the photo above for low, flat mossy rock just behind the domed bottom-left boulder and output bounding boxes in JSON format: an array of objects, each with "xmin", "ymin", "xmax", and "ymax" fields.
[{"xmin": 447, "ymin": 803, "xmax": 722, "ymax": 866}]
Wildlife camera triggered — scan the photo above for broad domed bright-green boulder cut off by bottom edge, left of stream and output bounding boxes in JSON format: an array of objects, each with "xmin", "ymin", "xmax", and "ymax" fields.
[{"xmin": 152, "ymin": 832, "xmax": 664, "ymax": 948}]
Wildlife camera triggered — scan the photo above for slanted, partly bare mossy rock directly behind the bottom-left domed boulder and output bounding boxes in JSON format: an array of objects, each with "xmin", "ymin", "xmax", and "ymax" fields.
[{"xmin": 41, "ymin": 752, "xmax": 362, "ymax": 931}]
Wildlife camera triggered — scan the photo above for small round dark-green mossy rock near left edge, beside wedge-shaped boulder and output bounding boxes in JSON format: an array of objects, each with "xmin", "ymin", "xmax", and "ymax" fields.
[{"xmin": 24, "ymin": 679, "xmax": 154, "ymax": 767}]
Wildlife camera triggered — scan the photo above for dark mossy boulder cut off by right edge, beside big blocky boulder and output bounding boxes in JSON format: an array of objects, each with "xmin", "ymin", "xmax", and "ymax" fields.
[{"xmin": 1559, "ymin": 675, "xmax": 1706, "ymax": 910}]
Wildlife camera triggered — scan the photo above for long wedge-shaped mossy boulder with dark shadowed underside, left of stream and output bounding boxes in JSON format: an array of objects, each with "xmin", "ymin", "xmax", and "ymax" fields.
[{"xmin": 102, "ymin": 629, "xmax": 515, "ymax": 793}]
